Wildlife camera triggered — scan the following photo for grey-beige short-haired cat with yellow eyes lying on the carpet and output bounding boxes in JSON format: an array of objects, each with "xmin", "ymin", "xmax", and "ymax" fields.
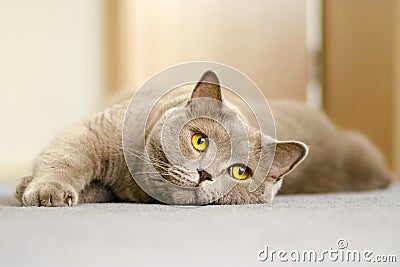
[{"xmin": 15, "ymin": 71, "xmax": 392, "ymax": 207}]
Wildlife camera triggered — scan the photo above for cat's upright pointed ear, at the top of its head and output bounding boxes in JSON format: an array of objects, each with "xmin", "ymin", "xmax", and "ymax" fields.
[{"xmin": 190, "ymin": 70, "xmax": 222, "ymax": 102}]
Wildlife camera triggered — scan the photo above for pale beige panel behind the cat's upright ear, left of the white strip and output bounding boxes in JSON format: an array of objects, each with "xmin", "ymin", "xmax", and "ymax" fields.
[{"xmin": 109, "ymin": 0, "xmax": 306, "ymax": 99}]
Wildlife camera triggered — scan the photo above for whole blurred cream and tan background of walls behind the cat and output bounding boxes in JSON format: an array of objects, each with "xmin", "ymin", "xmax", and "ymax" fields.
[{"xmin": 0, "ymin": 0, "xmax": 400, "ymax": 183}]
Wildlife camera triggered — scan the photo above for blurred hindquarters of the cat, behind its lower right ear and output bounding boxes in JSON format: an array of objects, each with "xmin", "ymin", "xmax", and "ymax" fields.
[{"xmin": 270, "ymin": 100, "xmax": 392, "ymax": 194}]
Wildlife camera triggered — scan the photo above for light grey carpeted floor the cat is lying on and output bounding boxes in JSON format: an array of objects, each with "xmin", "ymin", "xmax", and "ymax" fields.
[{"xmin": 0, "ymin": 181, "xmax": 400, "ymax": 267}]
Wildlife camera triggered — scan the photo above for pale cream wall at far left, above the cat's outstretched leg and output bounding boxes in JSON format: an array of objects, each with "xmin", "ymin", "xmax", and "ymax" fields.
[{"xmin": 0, "ymin": 0, "xmax": 105, "ymax": 181}]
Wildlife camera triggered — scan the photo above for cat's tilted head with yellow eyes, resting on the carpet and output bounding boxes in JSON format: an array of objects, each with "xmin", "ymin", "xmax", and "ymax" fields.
[{"xmin": 146, "ymin": 71, "xmax": 308, "ymax": 204}]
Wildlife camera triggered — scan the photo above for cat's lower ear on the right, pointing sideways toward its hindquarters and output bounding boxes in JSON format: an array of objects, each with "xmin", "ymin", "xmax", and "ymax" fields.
[{"xmin": 267, "ymin": 141, "xmax": 308, "ymax": 181}]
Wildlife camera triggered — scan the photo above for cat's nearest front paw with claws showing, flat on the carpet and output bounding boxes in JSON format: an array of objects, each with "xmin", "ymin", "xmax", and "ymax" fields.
[{"xmin": 22, "ymin": 181, "xmax": 78, "ymax": 207}]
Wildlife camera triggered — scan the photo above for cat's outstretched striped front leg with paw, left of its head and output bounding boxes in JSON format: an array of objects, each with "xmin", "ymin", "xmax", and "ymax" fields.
[{"xmin": 16, "ymin": 103, "xmax": 125, "ymax": 206}]
